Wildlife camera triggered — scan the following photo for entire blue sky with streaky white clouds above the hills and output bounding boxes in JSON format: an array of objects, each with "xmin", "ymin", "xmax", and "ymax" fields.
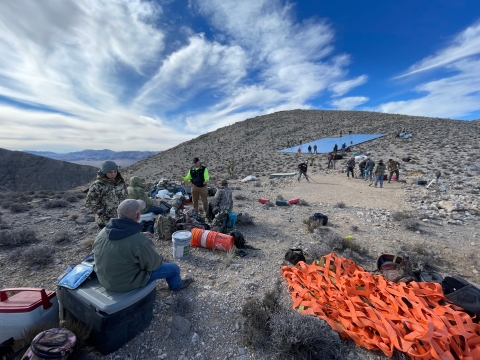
[{"xmin": 0, "ymin": 0, "xmax": 480, "ymax": 152}]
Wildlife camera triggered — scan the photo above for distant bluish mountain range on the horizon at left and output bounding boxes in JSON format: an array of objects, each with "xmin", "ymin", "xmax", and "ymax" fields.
[{"xmin": 24, "ymin": 149, "xmax": 160, "ymax": 162}]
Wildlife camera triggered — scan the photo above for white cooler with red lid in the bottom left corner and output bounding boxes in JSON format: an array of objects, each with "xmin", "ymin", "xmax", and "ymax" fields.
[{"xmin": 0, "ymin": 288, "xmax": 59, "ymax": 343}]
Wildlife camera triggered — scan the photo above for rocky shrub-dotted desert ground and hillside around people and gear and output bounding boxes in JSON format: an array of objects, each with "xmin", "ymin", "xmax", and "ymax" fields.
[{"xmin": 0, "ymin": 110, "xmax": 480, "ymax": 359}]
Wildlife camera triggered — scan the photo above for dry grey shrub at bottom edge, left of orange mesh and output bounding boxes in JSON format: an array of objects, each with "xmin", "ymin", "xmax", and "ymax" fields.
[{"xmin": 241, "ymin": 282, "xmax": 348, "ymax": 359}]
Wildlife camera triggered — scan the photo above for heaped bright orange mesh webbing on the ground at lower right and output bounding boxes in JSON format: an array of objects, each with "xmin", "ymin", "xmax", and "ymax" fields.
[{"xmin": 282, "ymin": 253, "xmax": 480, "ymax": 360}]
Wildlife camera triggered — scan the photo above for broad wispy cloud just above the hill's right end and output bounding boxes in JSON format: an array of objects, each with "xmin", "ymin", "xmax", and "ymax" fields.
[{"xmin": 376, "ymin": 59, "xmax": 480, "ymax": 117}]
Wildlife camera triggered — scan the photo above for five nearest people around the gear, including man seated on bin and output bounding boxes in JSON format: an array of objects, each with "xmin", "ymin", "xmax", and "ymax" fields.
[{"xmin": 85, "ymin": 158, "xmax": 233, "ymax": 292}]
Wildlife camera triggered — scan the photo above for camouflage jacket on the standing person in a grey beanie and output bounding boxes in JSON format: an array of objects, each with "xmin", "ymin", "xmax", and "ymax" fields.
[{"xmin": 85, "ymin": 173, "xmax": 127, "ymax": 225}]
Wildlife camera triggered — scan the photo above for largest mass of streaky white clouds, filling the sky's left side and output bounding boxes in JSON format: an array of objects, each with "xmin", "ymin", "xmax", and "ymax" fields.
[{"xmin": 0, "ymin": 0, "xmax": 366, "ymax": 150}]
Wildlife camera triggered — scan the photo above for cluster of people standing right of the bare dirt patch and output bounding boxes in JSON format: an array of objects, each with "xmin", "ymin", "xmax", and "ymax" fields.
[{"xmin": 347, "ymin": 157, "xmax": 400, "ymax": 188}]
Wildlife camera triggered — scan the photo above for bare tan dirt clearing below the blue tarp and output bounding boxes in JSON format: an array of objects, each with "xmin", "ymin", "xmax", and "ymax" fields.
[{"xmin": 282, "ymin": 172, "xmax": 411, "ymax": 210}]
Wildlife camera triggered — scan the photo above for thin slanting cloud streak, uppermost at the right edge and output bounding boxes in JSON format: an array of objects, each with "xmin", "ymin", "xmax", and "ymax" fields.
[{"xmin": 398, "ymin": 22, "xmax": 480, "ymax": 78}]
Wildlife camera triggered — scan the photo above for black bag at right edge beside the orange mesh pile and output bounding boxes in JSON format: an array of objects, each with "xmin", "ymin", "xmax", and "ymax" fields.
[{"xmin": 442, "ymin": 276, "xmax": 480, "ymax": 316}]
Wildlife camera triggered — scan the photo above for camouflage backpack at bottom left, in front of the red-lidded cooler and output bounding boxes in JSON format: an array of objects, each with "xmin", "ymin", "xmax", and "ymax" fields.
[{"xmin": 22, "ymin": 328, "xmax": 77, "ymax": 360}]
